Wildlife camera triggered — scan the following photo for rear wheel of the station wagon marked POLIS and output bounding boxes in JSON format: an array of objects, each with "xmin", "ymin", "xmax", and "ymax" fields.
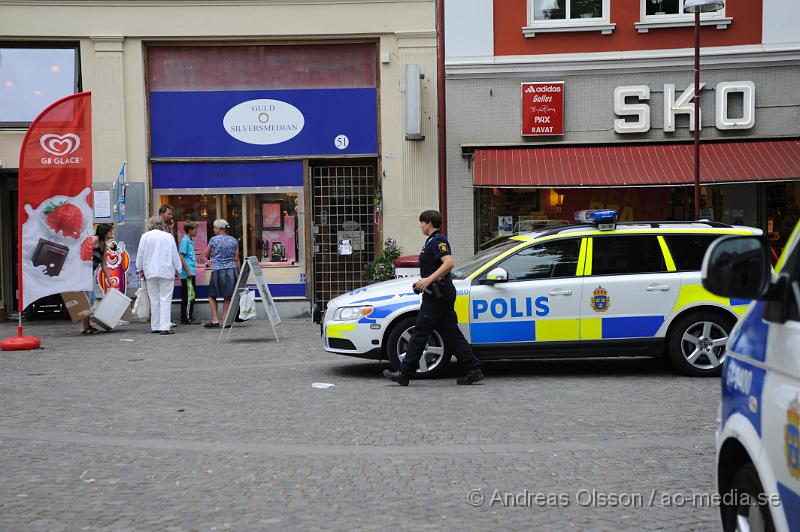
[{"xmin": 668, "ymin": 312, "xmax": 734, "ymax": 377}]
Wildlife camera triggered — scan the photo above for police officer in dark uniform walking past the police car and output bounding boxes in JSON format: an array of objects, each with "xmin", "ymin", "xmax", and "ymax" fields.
[{"xmin": 383, "ymin": 211, "xmax": 483, "ymax": 386}]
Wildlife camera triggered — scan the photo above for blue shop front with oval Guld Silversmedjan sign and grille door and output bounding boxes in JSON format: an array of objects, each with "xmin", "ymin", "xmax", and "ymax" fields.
[{"xmin": 147, "ymin": 42, "xmax": 380, "ymax": 304}]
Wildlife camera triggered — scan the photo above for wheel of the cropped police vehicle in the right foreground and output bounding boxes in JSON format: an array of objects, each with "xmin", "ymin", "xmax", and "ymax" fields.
[{"xmin": 722, "ymin": 464, "xmax": 775, "ymax": 532}]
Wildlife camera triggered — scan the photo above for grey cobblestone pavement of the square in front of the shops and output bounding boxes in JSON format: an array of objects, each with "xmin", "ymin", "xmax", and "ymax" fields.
[{"xmin": 0, "ymin": 320, "xmax": 719, "ymax": 530}]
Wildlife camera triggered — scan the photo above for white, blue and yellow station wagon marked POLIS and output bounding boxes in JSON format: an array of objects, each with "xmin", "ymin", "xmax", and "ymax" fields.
[{"xmin": 322, "ymin": 210, "xmax": 761, "ymax": 377}]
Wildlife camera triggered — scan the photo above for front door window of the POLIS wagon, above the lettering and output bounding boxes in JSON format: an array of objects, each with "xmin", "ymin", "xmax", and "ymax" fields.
[{"xmin": 498, "ymin": 238, "xmax": 581, "ymax": 281}]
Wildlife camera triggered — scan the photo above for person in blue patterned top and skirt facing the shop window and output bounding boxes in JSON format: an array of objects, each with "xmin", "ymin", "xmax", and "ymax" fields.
[{"xmin": 204, "ymin": 218, "xmax": 239, "ymax": 329}]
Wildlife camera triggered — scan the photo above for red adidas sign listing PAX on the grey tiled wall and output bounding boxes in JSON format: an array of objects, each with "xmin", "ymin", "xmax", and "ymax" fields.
[{"xmin": 522, "ymin": 81, "xmax": 564, "ymax": 137}]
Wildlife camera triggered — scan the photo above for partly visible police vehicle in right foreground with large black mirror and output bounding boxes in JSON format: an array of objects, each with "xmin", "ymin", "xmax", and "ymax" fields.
[{"xmin": 702, "ymin": 219, "xmax": 800, "ymax": 531}]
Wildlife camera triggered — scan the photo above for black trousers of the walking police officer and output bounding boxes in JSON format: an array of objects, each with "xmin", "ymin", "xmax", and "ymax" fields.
[{"xmin": 400, "ymin": 282, "xmax": 481, "ymax": 376}]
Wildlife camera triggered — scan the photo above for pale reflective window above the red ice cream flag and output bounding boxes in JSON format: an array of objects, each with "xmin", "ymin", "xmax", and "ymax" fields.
[{"xmin": 0, "ymin": 45, "xmax": 80, "ymax": 127}]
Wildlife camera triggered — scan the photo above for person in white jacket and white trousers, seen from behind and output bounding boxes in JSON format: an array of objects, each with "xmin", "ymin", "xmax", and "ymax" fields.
[{"xmin": 136, "ymin": 216, "xmax": 181, "ymax": 335}]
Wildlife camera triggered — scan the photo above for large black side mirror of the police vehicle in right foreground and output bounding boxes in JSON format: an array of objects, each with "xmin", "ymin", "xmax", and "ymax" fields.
[{"xmin": 702, "ymin": 236, "xmax": 772, "ymax": 299}]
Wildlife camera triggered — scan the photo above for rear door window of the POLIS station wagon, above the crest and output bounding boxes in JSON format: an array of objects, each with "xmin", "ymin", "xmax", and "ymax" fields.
[{"xmin": 592, "ymin": 235, "xmax": 667, "ymax": 275}]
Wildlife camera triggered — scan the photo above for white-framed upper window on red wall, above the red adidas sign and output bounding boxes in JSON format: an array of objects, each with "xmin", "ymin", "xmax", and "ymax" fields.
[{"xmin": 522, "ymin": 0, "xmax": 614, "ymax": 37}]
